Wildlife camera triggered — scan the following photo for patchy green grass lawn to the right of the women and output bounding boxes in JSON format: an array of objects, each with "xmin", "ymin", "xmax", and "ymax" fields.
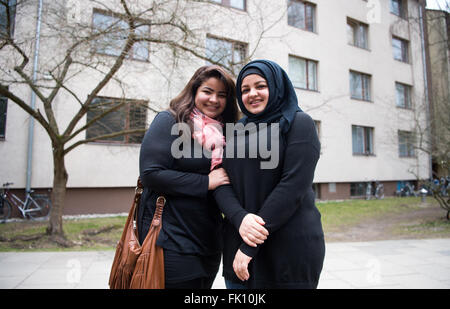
[{"xmin": 317, "ymin": 197, "xmax": 450, "ymax": 241}]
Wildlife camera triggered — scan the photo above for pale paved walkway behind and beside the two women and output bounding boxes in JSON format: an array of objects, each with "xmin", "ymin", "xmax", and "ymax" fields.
[{"xmin": 0, "ymin": 239, "xmax": 450, "ymax": 289}]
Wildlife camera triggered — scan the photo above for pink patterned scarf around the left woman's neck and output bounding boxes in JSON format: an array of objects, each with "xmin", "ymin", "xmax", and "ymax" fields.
[{"xmin": 191, "ymin": 107, "xmax": 225, "ymax": 171}]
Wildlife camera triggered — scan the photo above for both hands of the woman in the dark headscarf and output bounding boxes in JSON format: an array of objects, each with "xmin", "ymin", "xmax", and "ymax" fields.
[{"xmin": 233, "ymin": 214, "xmax": 269, "ymax": 281}]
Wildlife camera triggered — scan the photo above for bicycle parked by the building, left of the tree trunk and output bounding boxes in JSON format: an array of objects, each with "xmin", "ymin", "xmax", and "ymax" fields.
[{"xmin": 0, "ymin": 182, "xmax": 52, "ymax": 223}]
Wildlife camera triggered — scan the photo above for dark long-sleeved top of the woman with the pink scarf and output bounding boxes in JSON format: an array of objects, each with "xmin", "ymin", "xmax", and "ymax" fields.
[{"xmin": 139, "ymin": 111, "xmax": 223, "ymax": 255}]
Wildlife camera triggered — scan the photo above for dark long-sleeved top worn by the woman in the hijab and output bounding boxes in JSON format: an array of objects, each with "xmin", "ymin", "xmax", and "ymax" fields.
[{"xmin": 214, "ymin": 112, "xmax": 325, "ymax": 288}]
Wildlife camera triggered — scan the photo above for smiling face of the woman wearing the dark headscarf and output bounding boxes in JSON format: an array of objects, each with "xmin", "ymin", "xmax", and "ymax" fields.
[{"xmin": 241, "ymin": 74, "xmax": 269, "ymax": 114}]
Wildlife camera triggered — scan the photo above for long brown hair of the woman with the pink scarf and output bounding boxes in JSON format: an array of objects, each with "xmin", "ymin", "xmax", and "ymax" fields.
[{"xmin": 169, "ymin": 65, "xmax": 238, "ymax": 129}]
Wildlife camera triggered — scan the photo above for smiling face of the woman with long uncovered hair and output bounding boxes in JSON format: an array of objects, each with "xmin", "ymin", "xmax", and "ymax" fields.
[{"xmin": 194, "ymin": 77, "xmax": 227, "ymax": 119}]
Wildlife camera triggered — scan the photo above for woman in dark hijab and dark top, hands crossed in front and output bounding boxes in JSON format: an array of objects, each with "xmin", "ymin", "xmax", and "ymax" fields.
[{"xmin": 214, "ymin": 60, "xmax": 325, "ymax": 289}]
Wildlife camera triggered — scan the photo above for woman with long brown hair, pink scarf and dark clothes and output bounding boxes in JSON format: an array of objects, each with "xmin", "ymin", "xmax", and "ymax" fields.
[{"xmin": 138, "ymin": 66, "xmax": 238, "ymax": 288}]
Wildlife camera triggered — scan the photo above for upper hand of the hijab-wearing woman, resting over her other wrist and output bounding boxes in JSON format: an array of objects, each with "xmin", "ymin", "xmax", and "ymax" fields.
[{"xmin": 239, "ymin": 214, "xmax": 269, "ymax": 247}]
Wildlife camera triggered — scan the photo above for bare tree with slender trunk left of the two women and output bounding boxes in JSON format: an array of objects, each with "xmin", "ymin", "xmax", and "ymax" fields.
[{"xmin": 0, "ymin": 0, "xmax": 282, "ymax": 236}]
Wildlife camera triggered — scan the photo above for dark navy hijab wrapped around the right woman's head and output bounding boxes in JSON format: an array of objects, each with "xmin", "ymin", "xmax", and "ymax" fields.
[{"xmin": 236, "ymin": 60, "xmax": 302, "ymax": 135}]
